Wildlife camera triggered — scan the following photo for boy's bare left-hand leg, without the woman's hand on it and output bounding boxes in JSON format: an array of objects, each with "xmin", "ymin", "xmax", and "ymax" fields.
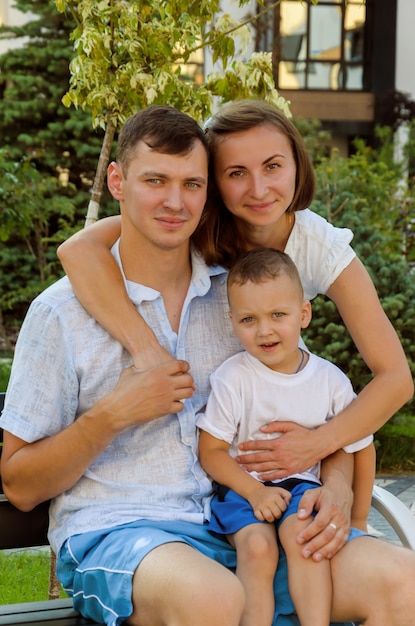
[{"xmin": 228, "ymin": 523, "xmax": 278, "ymax": 626}]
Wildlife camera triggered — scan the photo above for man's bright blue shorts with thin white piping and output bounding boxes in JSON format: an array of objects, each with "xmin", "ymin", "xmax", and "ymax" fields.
[{"xmin": 57, "ymin": 520, "xmax": 365, "ymax": 626}]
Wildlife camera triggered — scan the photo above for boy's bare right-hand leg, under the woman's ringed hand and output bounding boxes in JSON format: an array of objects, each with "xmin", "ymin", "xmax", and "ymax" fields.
[{"xmin": 278, "ymin": 515, "xmax": 332, "ymax": 626}]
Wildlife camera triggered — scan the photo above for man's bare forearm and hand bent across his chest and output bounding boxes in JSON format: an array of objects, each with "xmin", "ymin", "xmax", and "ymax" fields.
[{"xmin": 1, "ymin": 361, "xmax": 193, "ymax": 511}]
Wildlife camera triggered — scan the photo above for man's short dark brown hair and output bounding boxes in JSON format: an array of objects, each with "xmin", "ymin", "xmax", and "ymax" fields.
[{"xmin": 117, "ymin": 105, "xmax": 209, "ymax": 176}]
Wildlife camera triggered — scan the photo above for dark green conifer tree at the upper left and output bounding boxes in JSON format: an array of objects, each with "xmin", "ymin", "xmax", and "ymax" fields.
[{"xmin": 0, "ymin": 0, "xmax": 112, "ymax": 213}]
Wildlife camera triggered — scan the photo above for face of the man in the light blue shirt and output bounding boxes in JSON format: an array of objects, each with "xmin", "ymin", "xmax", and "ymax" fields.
[{"xmin": 108, "ymin": 141, "xmax": 208, "ymax": 250}]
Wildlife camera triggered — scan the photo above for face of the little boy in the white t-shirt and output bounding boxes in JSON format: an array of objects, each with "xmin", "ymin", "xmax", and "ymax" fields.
[{"xmin": 228, "ymin": 274, "xmax": 311, "ymax": 374}]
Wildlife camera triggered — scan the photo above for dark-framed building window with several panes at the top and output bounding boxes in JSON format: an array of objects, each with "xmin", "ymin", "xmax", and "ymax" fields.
[{"xmin": 257, "ymin": 0, "xmax": 368, "ymax": 91}]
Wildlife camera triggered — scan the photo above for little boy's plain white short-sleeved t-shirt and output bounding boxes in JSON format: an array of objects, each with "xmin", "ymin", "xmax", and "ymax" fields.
[{"xmin": 197, "ymin": 352, "xmax": 373, "ymax": 482}]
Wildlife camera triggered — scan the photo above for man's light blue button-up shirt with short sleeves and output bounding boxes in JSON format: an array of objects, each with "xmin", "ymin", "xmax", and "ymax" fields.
[{"xmin": 1, "ymin": 244, "xmax": 241, "ymax": 552}]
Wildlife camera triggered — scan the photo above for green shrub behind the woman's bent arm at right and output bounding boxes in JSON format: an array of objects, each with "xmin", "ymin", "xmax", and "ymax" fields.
[{"xmin": 304, "ymin": 138, "xmax": 415, "ymax": 416}]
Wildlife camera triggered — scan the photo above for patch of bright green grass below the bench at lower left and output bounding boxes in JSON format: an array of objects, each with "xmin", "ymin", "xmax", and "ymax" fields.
[{"xmin": 0, "ymin": 549, "xmax": 66, "ymax": 604}]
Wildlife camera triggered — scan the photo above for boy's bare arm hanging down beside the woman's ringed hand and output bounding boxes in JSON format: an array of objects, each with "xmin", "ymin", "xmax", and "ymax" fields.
[{"xmin": 352, "ymin": 444, "xmax": 376, "ymax": 532}]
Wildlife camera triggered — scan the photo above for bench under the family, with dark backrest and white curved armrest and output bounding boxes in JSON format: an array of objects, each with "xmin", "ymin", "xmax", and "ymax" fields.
[{"xmin": 0, "ymin": 393, "xmax": 415, "ymax": 626}]
